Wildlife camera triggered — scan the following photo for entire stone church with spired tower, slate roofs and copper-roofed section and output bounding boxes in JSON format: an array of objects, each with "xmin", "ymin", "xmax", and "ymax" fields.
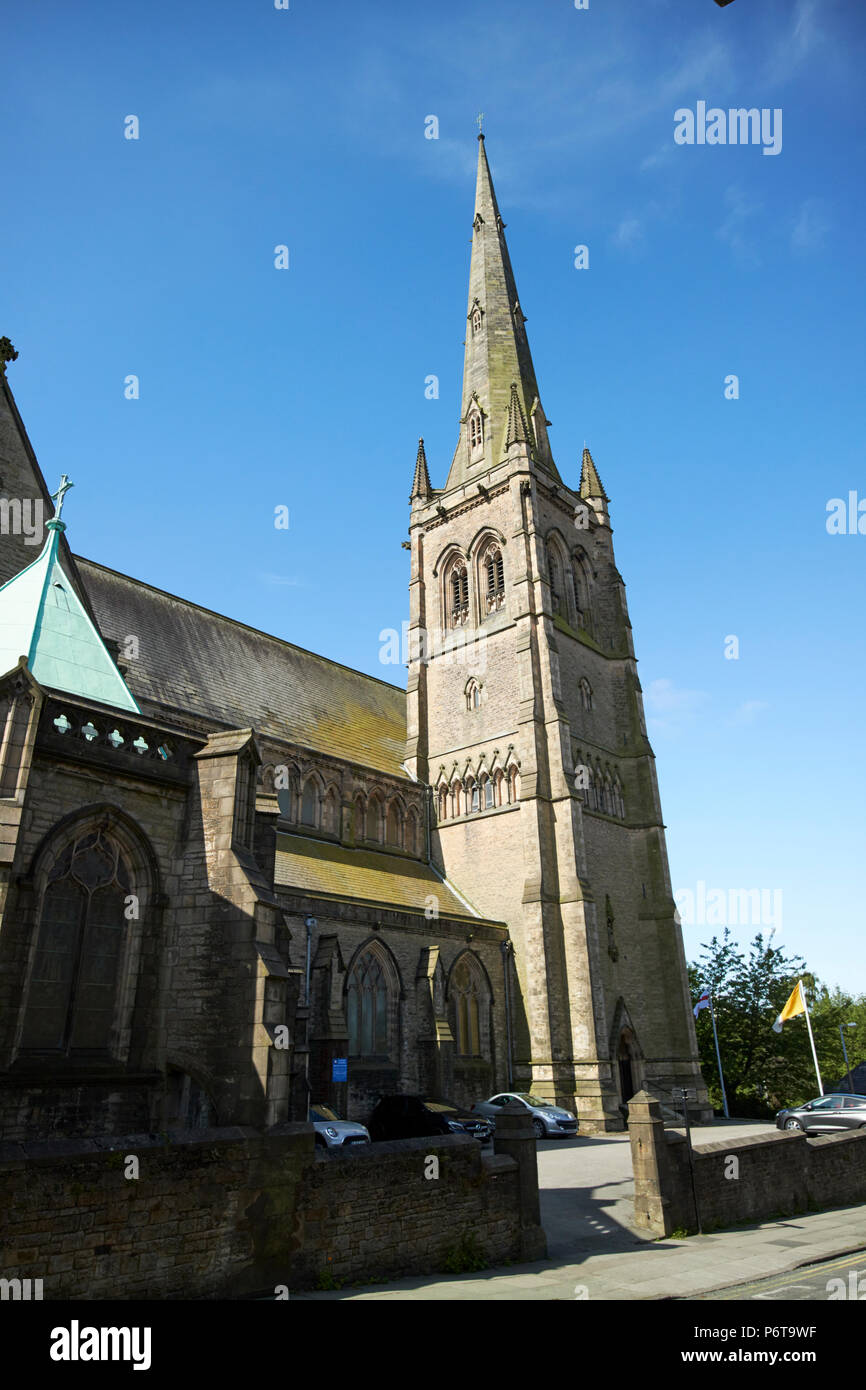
[{"xmin": 0, "ymin": 136, "xmax": 709, "ymax": 1140}]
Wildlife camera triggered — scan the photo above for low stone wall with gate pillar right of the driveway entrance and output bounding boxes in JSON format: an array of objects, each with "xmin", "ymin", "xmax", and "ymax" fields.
[{"xmin": 628, "ymin": 1091, "xmax": 866, "ymax": 1236}]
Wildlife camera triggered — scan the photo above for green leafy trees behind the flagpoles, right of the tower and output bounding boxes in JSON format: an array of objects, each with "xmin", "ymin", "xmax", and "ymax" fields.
[{"xmin": 688, "ymin": 927, "xmax": 866, "ymax": 1119}]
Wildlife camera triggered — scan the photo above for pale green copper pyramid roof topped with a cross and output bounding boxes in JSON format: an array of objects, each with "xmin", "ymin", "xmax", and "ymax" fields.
[{"xmin": 0, "ymin": 520, "xmax": 140, "ymax": 714}]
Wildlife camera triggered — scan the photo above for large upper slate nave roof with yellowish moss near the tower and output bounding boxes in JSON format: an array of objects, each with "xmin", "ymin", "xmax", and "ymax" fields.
[{"xmin": 76, "ymin": 556, "xmax": 407, "ymax": 778}]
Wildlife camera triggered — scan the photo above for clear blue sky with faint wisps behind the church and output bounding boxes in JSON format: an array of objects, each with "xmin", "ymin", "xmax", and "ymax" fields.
[{"xmin": 6, "ymin": 0, "xmax": 866, "ymax": 990}]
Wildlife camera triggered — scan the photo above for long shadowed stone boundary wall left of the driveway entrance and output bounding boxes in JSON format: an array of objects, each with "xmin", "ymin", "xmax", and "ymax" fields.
[{"xmin": 0, "ymin": 1116, "xmax": 545, "ymax": 1300}]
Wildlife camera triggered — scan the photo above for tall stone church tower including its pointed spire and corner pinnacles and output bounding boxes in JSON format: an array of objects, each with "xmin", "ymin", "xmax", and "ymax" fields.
[{"xmin": 406, "ymin": 136, "xmax": 709, "ymax": 1130}]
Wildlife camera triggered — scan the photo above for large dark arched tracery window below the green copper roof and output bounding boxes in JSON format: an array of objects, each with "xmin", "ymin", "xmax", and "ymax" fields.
[{"xmin": 21, "ymin": 830, "xmax": 131, "ymax": 1052}]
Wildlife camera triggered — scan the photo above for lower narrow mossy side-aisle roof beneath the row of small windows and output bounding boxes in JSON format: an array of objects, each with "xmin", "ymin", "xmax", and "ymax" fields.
[{"xmin": 274, "ymin": 831, "xmax": 492, "ymax": 922}]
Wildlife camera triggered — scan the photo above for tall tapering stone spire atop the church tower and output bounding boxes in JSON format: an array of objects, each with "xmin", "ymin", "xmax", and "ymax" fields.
[{"xmin": 446, "ymin": 135, "xmax": 559, "ymax": 489}]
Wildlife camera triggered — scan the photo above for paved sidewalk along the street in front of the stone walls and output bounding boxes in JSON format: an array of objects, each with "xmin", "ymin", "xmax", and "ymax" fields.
[{"xmin": 292, "ymin": 1207, "xmax": 866, "ymax": 1301}]
